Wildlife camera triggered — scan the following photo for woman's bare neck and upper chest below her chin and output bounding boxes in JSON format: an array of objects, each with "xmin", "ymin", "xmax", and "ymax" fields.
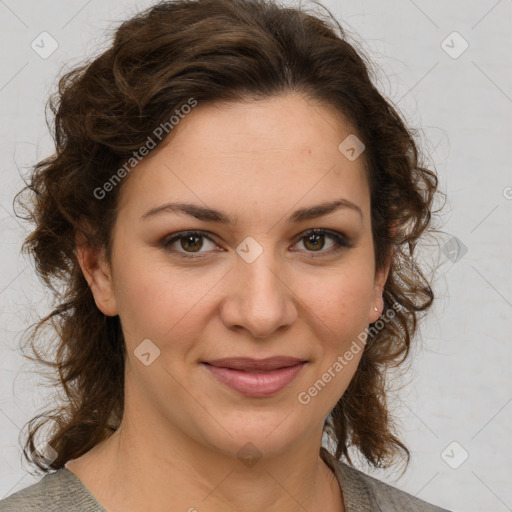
[{"xmin": 66, "ymin": 410, "xmax": 344, "ymax": 512}]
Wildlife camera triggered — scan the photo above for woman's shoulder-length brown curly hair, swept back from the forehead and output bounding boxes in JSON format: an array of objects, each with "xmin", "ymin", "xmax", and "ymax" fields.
[{"xmin": 15, "ymin": 0, "xmax": 438, "ymax": 472}]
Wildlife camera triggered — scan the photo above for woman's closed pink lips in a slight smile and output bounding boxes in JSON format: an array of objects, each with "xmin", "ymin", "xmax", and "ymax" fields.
[{"xmin": 202, "ymin": 357, "xmax": 306, "ymax": 398}]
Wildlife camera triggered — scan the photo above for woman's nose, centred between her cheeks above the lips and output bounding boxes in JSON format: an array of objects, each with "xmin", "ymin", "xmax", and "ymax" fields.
[{"xmin": 220, "ymin": 251, "xmax": 297, "ymax": 338}]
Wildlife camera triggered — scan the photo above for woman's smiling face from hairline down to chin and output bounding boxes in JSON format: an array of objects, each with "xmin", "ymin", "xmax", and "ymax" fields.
[{"xmin": 84, "ymin": 94, "xmax": 387, "ymax": 455}]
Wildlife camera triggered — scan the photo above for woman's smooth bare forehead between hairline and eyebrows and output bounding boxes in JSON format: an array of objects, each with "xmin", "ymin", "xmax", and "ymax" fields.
[{"xmin": 116, "ymin": 94, "xmax": 369, "ymax": 222}]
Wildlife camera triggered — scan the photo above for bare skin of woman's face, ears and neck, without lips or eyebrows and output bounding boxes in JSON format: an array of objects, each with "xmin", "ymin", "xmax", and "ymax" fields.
[{"xmin": 66, "ymin": 93, "xmax": 389, "ymax": 512}]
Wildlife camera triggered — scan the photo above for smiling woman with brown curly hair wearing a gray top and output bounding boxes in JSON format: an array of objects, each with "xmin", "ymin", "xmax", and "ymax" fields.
[{"xmin": 0, "ymin": 0, "xmax": 450, "ymax": 512}]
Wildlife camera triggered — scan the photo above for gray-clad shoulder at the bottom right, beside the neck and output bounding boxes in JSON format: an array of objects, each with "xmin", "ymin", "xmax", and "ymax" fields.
[{"xmin": 324, "ymin": 450, "xmax": 450, "ymax": 512}]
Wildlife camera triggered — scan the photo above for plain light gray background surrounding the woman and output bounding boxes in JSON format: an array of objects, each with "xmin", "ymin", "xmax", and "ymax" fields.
[{"xmin": 0, "ymin": 0, "xmax": 512, "ymax": 512}]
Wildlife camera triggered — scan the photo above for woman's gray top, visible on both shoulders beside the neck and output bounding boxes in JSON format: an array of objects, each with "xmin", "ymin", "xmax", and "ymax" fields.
[{"xmin": 0, "ymin": 450, "xmax": 450, "ymax": 512}]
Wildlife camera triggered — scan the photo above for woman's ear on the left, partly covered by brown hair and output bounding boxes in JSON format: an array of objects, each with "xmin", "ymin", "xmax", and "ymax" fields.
[{"xmin": 76, "ymin": 237, "xmax": 118, "ymax": 316}]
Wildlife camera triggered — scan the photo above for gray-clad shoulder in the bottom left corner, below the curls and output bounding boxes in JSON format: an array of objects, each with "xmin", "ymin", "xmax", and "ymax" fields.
[{"xmin": 0, "ymin": 468, "xmax": 104, "ymax": 512}]
